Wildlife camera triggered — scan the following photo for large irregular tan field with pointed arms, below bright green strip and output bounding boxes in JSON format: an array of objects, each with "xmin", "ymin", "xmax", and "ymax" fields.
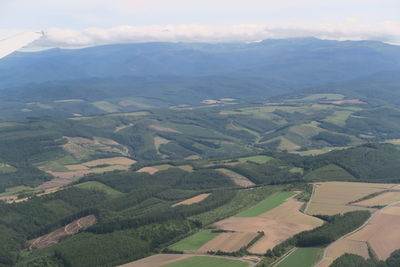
[{"xmin": 215, "ymin": 198, "xmax": 323, "ymax": 254}]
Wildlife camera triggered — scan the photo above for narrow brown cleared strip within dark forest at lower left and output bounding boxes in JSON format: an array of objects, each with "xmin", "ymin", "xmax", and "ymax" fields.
[{"xmin": 28, "ymin": 215, "xmax": 97, "ymax": 248}]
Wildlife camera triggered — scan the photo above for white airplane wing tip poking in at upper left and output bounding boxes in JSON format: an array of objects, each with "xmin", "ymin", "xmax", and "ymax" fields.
[{"xmin": 0, "ymin": 32, "xmax": 44, "ymax": 59}]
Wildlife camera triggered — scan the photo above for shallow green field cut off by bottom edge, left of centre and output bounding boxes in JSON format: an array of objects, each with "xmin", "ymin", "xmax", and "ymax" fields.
[{"xmin": 161, "ymin": 256, "xmax": 249, "ymax": 267}]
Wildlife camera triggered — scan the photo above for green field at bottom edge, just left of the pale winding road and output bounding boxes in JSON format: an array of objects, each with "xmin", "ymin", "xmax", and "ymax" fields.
[{"xmin": 275, "ymin": 248, "xmax": 322, "ymax": 267}]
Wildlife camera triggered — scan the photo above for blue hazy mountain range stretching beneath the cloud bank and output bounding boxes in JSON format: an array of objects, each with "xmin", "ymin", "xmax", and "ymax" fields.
[{"xmin": 0, "ymin": 38, "xmax": 400, "ymax": 118}]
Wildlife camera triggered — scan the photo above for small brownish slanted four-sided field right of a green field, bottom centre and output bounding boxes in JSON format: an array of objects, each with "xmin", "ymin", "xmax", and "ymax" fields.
[{"xmin": 197, "ymin": 232, "xmax": 257, "ymax": 253}]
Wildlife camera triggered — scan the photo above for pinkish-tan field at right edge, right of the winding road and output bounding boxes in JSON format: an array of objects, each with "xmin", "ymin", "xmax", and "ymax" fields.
[{"xmin": 347, "ymin": 204, "xmax": 400, "ymax": 260}]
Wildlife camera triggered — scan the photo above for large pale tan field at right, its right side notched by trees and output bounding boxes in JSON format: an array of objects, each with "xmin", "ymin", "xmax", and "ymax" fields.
[{"xmin": 307, "ymin": 182, "xmax": 394, "ymax": 215}]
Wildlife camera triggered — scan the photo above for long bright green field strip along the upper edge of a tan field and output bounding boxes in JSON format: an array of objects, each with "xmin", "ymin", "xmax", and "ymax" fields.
[{"xmin": 236, "ymin": 192, "xmax": 295, "ymax": 217}]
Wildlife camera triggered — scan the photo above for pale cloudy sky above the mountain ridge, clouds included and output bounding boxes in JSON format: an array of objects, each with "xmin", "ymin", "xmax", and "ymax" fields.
[{"xmin": 0, "ymin": 0, "xmax": 400, "ymax": 48}]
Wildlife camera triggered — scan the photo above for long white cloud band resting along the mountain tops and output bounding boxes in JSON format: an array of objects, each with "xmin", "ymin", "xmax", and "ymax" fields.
[{"xmin": 27, "ymin": 20, "xmax": 400, "ymax": 48}]
